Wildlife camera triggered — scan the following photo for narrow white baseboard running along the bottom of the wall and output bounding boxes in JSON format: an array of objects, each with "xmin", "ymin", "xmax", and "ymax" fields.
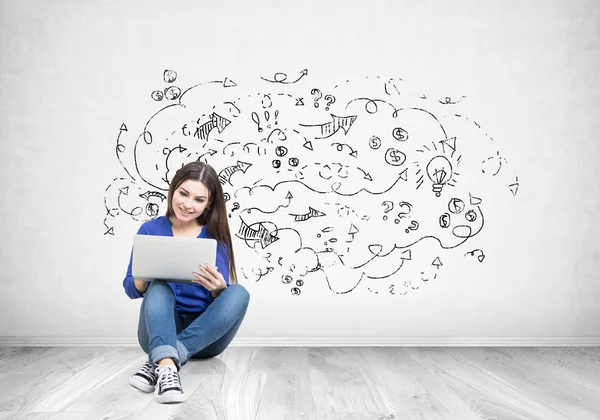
[{"xmin": 0, "ymin": 337, "xmax": 600, "ymax": 347}]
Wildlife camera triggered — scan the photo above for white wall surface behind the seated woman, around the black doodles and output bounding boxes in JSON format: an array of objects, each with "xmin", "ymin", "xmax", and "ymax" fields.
[{"xmin": 0, "ymin": 0, "xmax": 600, "ymax": 344}]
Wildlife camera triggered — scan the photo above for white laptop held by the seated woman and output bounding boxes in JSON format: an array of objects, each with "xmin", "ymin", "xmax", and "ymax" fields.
[{"xmin": 131, "ymin": 235, "xmax": 217, "ymax": 283}]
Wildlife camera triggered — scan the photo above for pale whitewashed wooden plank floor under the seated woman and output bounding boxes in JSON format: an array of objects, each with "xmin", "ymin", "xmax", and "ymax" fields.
[{"xmin": 0, "ymin": 347, "xmax": 600, "ymax": 420}]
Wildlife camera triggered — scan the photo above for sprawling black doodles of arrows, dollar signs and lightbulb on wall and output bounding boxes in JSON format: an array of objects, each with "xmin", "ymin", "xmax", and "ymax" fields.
[{"xmin": 103, "ymin": 69, "xmax": 519, "ymax": 296}]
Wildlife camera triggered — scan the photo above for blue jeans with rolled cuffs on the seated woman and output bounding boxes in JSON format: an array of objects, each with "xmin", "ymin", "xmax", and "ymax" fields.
[{"xmin": 138, "ymin": 280, "xmax": 250, "ymax": 368}]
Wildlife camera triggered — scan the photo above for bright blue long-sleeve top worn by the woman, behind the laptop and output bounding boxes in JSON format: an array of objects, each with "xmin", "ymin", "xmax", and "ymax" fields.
[{"xmin": 123, "ymin": 216, "xmax": 229, "ymax": 314}]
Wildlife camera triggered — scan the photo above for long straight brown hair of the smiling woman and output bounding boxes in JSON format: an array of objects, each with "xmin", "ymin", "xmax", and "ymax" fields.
[{"xmin": 166, "ymin": 162, "xmax": 237, "ymax": 284}]
